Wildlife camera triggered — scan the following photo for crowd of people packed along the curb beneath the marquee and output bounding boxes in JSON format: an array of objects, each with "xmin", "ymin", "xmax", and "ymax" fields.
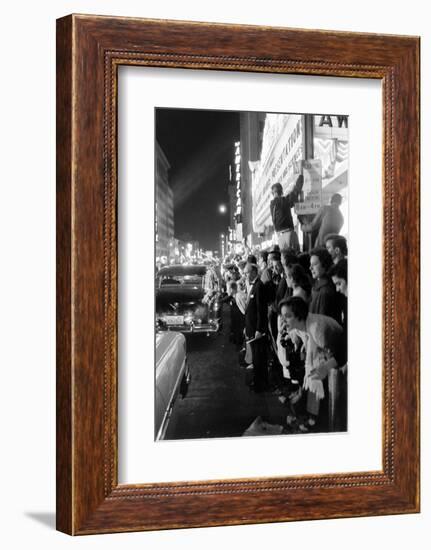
[{"xmin": 223, "ymin": 233, "xmax": 347, "ymax": 432}]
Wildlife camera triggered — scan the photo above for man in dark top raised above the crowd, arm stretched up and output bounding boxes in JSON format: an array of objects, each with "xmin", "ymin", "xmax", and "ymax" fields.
[{"xmin": 269, "ymin": 175, "xmax": 304, "ymax": 250}]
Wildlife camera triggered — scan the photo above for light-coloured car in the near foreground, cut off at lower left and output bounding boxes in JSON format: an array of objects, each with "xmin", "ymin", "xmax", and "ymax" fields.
[{"xmin": 154, "ymin": 332, "xmax": 191, "ymax": 441}]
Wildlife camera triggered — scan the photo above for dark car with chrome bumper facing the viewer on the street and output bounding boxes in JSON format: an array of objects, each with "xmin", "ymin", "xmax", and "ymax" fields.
[{"xmin": 156, "ymin": 265, "xmax": 221, "ymax": 334}]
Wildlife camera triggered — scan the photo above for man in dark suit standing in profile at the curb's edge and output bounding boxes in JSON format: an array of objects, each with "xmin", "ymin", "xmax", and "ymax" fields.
[{"xmin": 244, "ymin": 263, "xmax": 268, "ymax": 392}]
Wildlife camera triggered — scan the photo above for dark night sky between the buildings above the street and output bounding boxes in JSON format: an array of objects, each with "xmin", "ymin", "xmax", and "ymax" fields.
[{"xmin": 156, "ymin": 109, "xmax": 239, "ymax": 250}]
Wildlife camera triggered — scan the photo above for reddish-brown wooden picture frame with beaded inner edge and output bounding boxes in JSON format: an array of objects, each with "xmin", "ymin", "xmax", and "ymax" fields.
[{"xmin": 57, "ymin": 15, "xmax": 420, "ymax": 534}]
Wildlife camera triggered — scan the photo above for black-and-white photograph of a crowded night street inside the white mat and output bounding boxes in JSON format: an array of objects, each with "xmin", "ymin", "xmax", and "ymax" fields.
[{"xmin": 154, "ymin": 108, "xmax": 349, "ymax": 440}]
